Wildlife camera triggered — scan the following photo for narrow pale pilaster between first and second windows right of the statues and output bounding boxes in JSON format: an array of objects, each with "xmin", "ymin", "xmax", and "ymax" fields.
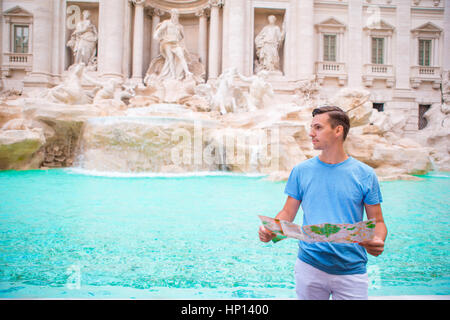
[{"xmin": 346, "ymin": 0, "xmax": 362, "ymax": 87}]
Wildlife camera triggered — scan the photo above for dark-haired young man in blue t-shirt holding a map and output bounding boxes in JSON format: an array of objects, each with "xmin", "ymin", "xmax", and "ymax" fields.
[{"xmin": 259, "ymin": 106, "xmax": 387, "ymax": 300}]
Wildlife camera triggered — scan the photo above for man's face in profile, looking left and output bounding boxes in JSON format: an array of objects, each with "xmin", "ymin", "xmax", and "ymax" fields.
[{"xmin": 309, "ymin": 113, "xmax": 343, "ymax": 150}]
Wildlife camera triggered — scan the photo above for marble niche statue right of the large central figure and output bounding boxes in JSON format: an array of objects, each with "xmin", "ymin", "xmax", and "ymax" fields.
[{"xmin": 255, "ymin": 15, "xmax": 285, "ymax": 73}]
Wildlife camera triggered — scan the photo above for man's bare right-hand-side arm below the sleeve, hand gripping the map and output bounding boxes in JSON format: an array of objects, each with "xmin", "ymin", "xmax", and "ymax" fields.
[{"xmin": 360, "ymin": 203, "xmax": 387, "ymax": 257}]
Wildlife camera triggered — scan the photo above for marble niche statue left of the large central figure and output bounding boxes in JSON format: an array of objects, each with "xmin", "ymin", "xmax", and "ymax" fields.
[{"xmin": 67, "ymin": 10, "xmax": 98, "ymax": 69}]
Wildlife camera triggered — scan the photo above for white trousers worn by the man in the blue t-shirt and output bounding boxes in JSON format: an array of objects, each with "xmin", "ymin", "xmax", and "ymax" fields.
[{"xmin": 295, "ymin": 258, "xmax": 369, "ymax": 300}]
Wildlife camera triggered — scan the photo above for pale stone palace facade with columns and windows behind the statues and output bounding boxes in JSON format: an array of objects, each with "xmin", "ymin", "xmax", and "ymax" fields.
[{"xmin": 0, "ymin": 0, "xmax": 450, "ymax": 134}]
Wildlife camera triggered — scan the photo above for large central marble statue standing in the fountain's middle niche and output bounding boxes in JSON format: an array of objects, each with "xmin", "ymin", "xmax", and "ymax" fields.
[{"xmin": 154, "ymin": 9, "xmax": 192, "ymax": 80}]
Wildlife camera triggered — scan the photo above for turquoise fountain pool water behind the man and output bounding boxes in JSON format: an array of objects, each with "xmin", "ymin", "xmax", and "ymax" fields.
[{"xmin": 0, "ymin": 169, "xmax": 450, "ymax": 299}]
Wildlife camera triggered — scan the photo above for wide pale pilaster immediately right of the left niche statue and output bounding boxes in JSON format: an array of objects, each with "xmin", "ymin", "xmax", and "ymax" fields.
[{"xmin": 98, "ymin": 0, "xmax": 127, "ymax": 79}]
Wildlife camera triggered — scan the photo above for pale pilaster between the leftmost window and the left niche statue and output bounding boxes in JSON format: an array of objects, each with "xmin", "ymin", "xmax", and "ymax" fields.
[{"xmin": 24, "ymin": 0, "xmax": 53, "ymax": 87}]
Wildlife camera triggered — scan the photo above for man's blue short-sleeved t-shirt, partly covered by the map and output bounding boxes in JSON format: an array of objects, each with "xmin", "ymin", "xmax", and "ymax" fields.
[{"xmin": 284, "ymin": 157, "xmax": 382, "ymax": 274}]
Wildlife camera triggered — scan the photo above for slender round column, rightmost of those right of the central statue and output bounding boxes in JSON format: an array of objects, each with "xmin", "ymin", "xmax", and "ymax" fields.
[{"xmin": 208, "ymin": 0, "xmax": 222, "ymax": 79}]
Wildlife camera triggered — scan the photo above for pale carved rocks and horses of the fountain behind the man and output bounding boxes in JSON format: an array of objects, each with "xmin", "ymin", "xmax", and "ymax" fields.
[{"xmin": 0, "ymin": 64, "xmax": 450, "ymax": 180}]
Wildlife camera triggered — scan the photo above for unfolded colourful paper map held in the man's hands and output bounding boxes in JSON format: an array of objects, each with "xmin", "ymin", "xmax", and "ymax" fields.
[{"xmin": 258, "ymin": 216, "xmax": 375, "ymax": 243}]
